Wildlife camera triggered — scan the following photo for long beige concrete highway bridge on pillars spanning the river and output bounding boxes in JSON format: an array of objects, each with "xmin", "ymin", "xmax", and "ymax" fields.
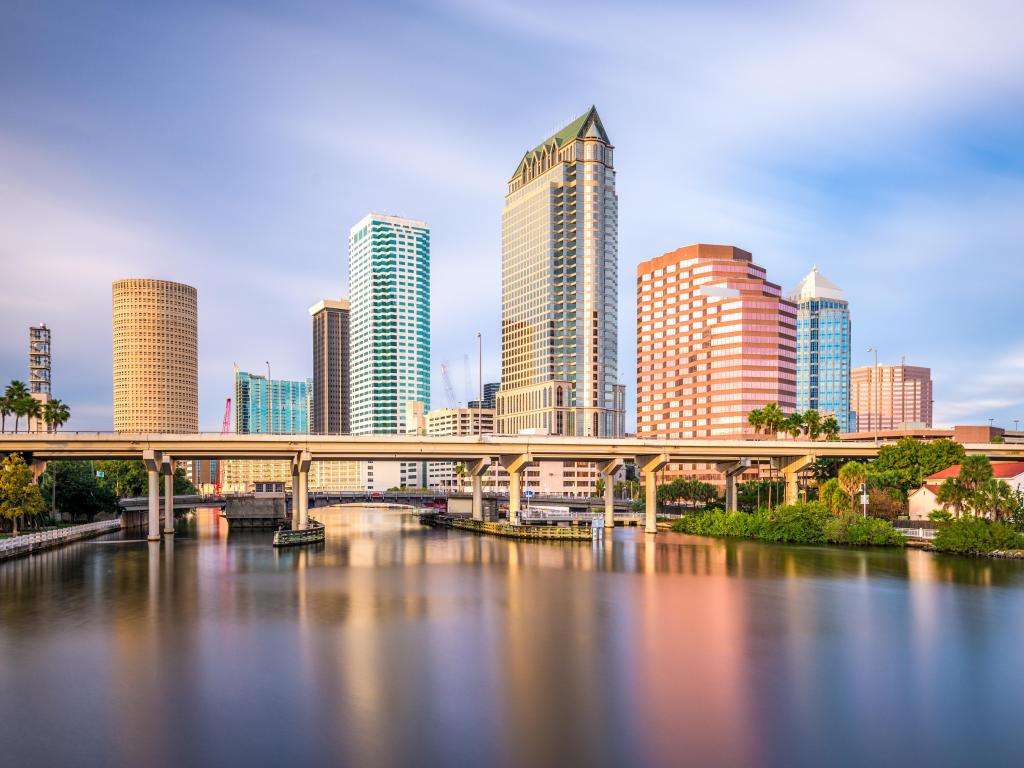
[{"xmin": 0, "ymin": 432, "xmax": 1024, "ymax": 539}]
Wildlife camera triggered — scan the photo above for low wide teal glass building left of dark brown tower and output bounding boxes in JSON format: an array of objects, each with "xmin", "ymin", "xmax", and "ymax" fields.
[{"xmin": 234, "ymin": 369, "xmax": 313, "ymax": 434}]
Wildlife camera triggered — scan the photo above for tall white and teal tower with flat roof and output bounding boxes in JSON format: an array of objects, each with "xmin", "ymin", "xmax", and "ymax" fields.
[{"xmin": 348, "ymin": 213, "xmax": 430, "ymax": 434}]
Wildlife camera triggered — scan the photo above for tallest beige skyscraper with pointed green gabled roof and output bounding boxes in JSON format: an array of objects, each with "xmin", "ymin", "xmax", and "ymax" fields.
[{"xmin": 497, "ymin": 106, "xmax": 626, "ymax": 436}]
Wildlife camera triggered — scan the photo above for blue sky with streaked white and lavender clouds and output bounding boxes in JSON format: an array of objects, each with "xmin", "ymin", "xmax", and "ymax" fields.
[{"xmin": 0, "ymin": 0, "xmax": 1024, "ymax": 431}]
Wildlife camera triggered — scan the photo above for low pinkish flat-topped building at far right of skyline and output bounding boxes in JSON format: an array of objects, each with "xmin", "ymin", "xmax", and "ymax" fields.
[{"xmin": 850, "ymin": 362, "xmax": 932, "ymax": 432}]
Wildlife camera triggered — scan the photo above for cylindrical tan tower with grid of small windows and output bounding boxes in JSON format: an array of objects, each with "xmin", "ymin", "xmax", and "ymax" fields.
[{"xmin": 114, "ymin": 278, "xmax": 199, "ymax": 433}]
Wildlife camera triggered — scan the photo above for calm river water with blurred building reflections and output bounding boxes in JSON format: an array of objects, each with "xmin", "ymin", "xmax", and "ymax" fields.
[{"xmin": 0, "ymin": 509, "xmax": 1024, "ymax": 766}]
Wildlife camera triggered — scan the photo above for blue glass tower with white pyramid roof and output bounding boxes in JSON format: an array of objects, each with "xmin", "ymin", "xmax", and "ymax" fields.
[{"xmin": 788, "ymin": 266, "xmax": 851, "ymax": 432}]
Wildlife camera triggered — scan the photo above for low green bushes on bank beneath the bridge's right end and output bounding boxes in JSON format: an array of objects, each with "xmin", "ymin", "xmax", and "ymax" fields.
[{"xmin": 672, "ymin": 502, "xmax": 904, "ymax": 547}]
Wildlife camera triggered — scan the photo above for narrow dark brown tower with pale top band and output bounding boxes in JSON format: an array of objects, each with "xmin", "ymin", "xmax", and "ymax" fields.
[{"xmin": 309, "ymin": 299, "xmax": 352, "ymax": 434}]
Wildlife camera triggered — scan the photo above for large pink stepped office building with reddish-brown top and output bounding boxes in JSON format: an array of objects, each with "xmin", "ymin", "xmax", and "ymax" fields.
[{"xmin": 637, "ymin": 245, "xmax": 797, "ymax": 439}]
